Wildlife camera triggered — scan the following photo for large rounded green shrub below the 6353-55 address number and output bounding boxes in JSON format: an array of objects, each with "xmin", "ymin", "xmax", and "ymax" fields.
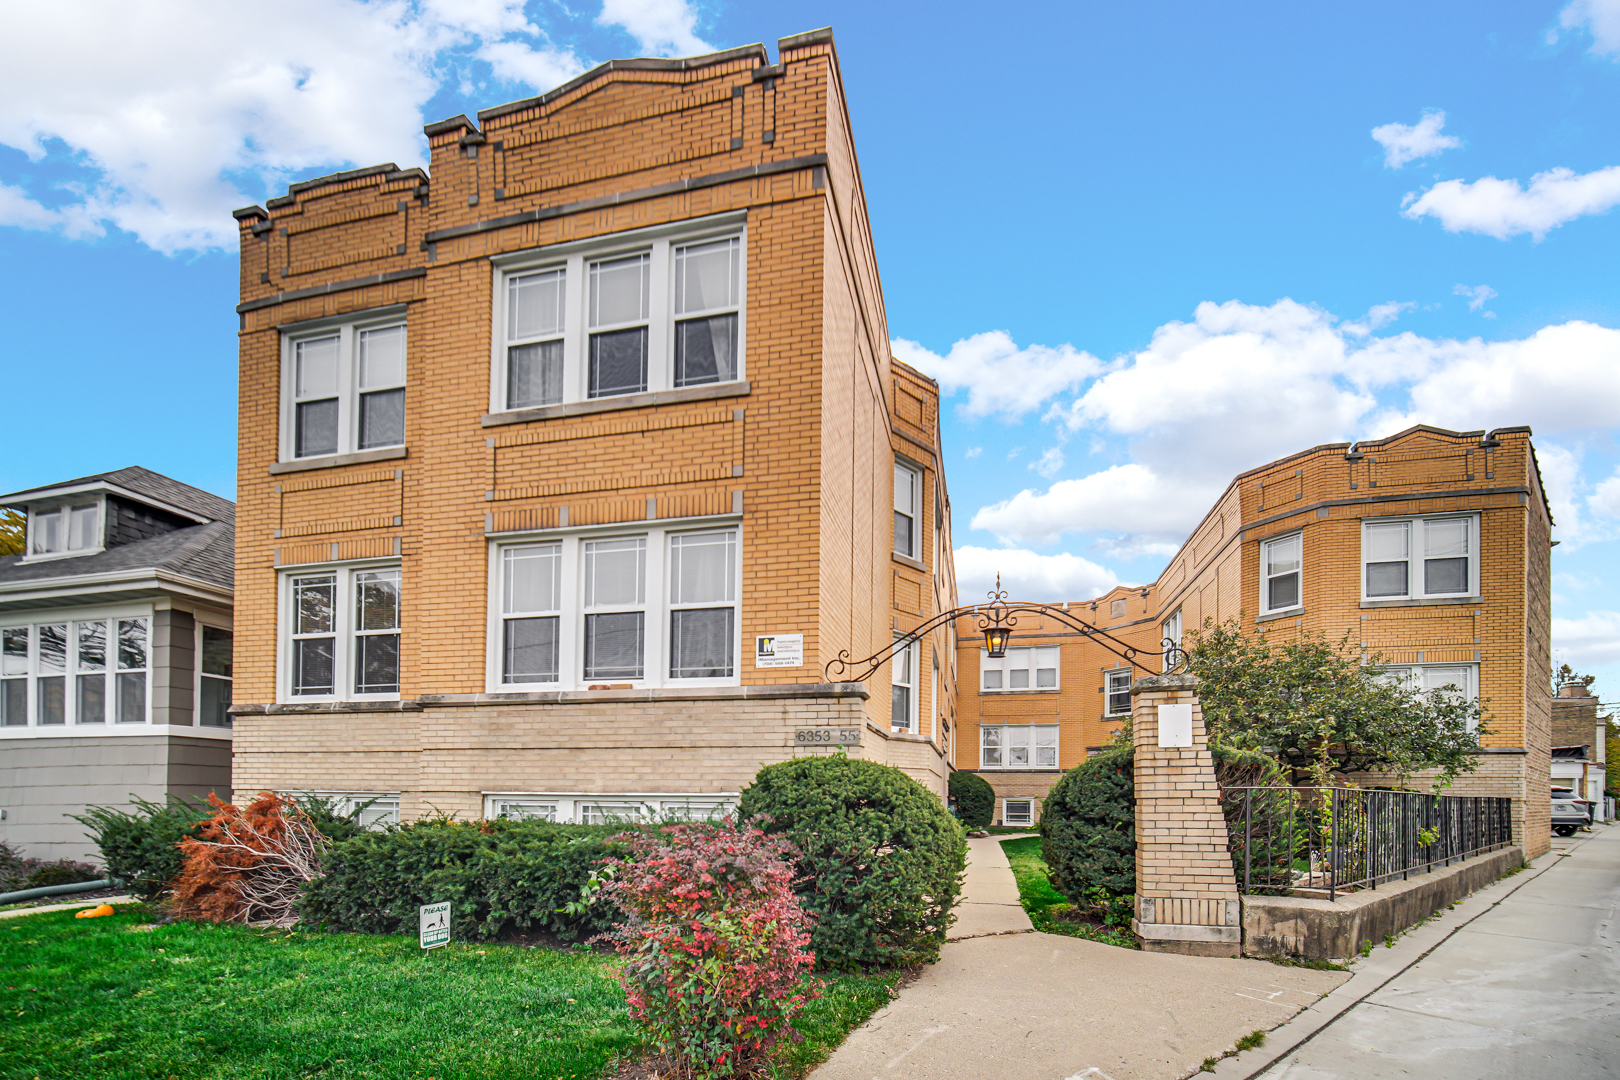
[{"xmin": 739, "ymin": 755, "xmax": 967, "ymax": 968}]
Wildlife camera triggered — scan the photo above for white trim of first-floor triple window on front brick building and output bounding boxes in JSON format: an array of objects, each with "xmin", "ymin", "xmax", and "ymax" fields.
[{"xmin": 484, "ymin": 515, "xmax": 745, "ymax": 693}]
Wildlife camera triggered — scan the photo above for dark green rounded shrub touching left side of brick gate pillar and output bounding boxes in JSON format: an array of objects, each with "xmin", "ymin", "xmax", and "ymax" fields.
[{"xmin": 1040, "ymin": 745, "xmax": 1136, "ymax": 910}]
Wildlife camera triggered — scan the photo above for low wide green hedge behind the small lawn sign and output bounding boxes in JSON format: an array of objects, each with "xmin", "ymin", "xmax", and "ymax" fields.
[{"xmin": 300, "ymin": 818, "xmax": 624, "ymax": 941}]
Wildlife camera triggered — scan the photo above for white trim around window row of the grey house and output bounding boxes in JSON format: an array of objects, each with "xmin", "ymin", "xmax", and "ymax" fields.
[{"xmin": 0, "ymin": 606, "xmax": 152, "ymax": 738}]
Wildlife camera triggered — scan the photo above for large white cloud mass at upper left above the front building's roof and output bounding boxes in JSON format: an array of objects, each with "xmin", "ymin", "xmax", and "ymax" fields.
[{"xmin": 0, "ymin": 0, "xmax": 583, "ymax": 253}]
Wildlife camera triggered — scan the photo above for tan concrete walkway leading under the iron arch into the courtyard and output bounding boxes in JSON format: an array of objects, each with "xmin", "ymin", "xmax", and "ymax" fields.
[{"xmin": 812, "ymin": 836, "xmax": 1349, "ymax": 1080}]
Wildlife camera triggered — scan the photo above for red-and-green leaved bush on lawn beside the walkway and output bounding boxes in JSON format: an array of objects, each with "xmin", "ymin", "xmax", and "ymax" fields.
[{"xmin": 601, "ymin": 818, "xmax": 820, "ymax": 1078}]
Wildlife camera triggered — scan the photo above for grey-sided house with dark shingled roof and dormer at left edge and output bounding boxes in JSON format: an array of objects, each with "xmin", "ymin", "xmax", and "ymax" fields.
[{"xmin": 0, "ymin": 468, "xmax": 235, "ymax": 861}]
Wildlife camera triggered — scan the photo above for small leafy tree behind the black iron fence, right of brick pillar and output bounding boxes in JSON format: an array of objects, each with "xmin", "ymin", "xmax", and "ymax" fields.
[{"xmin": 1187, "ymin": 619, "xmax": 1486, "ymax": 789}]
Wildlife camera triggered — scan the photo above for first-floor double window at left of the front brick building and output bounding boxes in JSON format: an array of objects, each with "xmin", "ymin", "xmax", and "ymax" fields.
[{"xmin": 280, "ymin": 565, "xmax": 400, "ymax": 701}]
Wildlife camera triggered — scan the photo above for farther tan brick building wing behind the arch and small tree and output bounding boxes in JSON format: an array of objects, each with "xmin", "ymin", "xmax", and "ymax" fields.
[{"xmin": 954, "ymin": 426, "xmax": 1555, "ymax": 857}]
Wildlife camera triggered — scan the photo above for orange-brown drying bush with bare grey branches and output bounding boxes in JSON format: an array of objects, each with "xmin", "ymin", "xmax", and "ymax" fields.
[{"xmin": 175, "ymin": 792, "xmax": 332, "ymax": 926}]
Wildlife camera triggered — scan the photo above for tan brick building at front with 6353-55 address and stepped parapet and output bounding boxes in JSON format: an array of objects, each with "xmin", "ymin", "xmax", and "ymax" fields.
[{"xmin": 233, "ymin": 31, "xmax": 956, "ymax": 821}]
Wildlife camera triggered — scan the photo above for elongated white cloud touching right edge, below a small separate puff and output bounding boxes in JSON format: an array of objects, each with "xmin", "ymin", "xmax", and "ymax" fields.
[{"xmin": 1401, "ymin": 165, "xmax": 1620, "ymax": 241}]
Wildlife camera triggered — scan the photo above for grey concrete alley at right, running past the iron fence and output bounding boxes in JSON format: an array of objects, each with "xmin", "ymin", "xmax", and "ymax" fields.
[{"xmin": 1217, "ymin": 826, "xmax": 1620, "ymax": 1080}]
